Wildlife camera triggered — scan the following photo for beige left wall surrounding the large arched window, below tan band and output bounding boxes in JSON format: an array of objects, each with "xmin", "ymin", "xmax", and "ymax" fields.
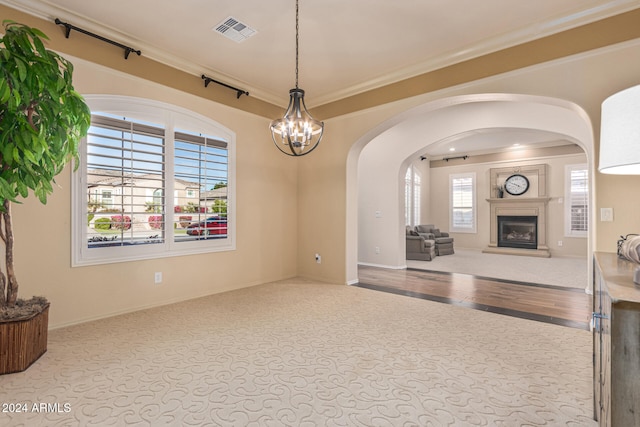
[{"xmin": 13, "ymin": 58, "xmax": 298, "ymax": 327}]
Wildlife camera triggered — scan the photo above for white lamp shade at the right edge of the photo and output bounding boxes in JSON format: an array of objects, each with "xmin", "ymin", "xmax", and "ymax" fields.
[{"xmin": 598, "ymin": 85, "xmax": 640, "ymax": 175}]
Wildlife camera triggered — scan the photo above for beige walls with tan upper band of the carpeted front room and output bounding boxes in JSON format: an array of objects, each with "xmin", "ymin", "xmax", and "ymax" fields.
[{"xmin": 0, "ymin": 5, "xmax": 640, "ymax": 326}]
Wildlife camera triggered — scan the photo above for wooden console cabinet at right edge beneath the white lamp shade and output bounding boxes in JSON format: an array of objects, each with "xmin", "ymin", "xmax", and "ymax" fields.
[{"xmin": 592, "ymin": 252, "xmax": 640, "ymax": 427}]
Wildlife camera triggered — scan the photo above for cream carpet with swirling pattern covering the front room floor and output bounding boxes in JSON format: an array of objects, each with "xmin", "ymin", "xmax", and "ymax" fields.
[{"xmin": 0, "ymin": 279, "xmax": 596, "ymax": 427}]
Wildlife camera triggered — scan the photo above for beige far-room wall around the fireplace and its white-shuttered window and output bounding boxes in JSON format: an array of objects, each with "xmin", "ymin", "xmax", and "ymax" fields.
[{"xmin": 427, "ymin": 154, "xmax": 588, "ymax": 261}]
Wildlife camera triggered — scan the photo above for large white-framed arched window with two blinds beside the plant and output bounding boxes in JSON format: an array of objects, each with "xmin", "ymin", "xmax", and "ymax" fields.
[{"xmin": 72, "ymin": 96, "xmax": 235, "ymax": 265}]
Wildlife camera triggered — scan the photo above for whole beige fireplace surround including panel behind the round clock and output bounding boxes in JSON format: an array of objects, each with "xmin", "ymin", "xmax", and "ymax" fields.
[{"xmin": 483, "ymin": 164, "xmax": 551, "ymax": 258}]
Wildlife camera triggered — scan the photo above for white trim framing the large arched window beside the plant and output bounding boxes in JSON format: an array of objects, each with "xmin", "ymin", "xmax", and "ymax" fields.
[{"xmin": 71, "ymin": 95, "xmax": 236, "ymax": 267}]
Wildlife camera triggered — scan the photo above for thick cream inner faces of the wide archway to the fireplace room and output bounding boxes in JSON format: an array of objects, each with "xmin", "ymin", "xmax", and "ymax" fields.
[{"xmin": 346, "ymin": 94, "xmax": 594, "ymax": 290}]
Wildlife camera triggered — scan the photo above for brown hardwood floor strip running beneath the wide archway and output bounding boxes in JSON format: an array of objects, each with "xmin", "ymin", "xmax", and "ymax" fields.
[{"xmin": 354, "ymin": 266, "xmax": 592, "ymax": 330}]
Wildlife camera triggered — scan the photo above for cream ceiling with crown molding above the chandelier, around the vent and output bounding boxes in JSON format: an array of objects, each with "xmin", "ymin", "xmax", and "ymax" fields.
[{"xmin": 0, "ymin": 0, "xmax": 639, "ymax": 107}]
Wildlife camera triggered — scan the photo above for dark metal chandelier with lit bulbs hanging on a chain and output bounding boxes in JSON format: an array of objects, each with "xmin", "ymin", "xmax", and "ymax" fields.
[{"xmin": 269, "ymin": 0, "xmax": 324, "ymax": 156}]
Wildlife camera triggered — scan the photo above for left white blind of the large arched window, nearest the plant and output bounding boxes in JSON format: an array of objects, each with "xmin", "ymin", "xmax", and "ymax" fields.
[{"xmin": 85, "ymin": 115, "xmax": 165, "ymax": 248}]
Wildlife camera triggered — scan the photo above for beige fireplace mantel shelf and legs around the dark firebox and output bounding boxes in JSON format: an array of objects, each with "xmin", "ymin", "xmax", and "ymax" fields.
[{"xmin": 483, "ymin": 197, "xmax": 551, "ymax": 258}]
